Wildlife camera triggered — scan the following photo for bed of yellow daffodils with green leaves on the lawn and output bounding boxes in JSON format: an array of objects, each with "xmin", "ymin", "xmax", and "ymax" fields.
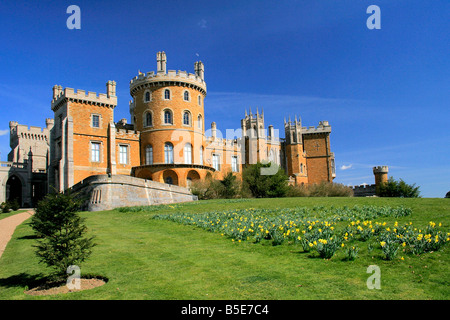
[{"xmin": 154, "ymin": 206, "xmax": 450, "ymax": 260}]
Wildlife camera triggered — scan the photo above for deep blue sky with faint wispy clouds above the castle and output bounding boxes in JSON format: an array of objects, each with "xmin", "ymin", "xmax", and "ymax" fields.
[{"xmin": 0, "ymin": 0, "xmax": 450, "ymax": 197}]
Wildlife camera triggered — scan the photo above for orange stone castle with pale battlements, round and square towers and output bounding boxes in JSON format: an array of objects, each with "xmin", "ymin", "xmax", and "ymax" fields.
[{"xmin": 0, "ymin": 52, "xmax": 336, "ymax": 206}]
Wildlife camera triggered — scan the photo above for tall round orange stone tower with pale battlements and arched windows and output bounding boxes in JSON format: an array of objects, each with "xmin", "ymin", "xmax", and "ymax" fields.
[{"xmin": 130, "ymin": 52, "xmax": 214, "ymax": 186}]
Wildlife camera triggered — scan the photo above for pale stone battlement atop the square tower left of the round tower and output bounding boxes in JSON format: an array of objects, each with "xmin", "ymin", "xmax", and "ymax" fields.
[{"xmin": 51, "ymin": 81, "xmax": 117, "ymax": 111}]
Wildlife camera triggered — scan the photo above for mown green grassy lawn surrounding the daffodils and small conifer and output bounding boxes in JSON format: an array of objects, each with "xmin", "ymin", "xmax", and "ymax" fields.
[{"xmin": 0, "ymin": 198, "xmax": 450, "ymax": 300}]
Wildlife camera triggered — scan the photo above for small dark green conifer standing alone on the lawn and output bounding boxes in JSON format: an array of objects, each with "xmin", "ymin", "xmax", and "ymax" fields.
[{"xmin": 30, "ymin": 193, "xmax": 95, "ymax": 276}]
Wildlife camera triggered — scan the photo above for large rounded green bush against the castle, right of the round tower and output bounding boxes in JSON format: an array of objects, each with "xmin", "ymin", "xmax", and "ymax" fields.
[{"xmin": 242, "ymin": 162, "xmax": 288, "ymax": 198}]
